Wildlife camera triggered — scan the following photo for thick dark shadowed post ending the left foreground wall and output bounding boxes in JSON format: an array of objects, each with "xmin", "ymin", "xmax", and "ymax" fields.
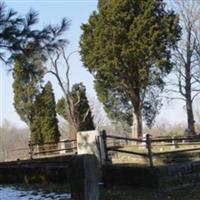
[{"xmin": 69, "ymin": 154, "xmax": 99, "ymax": 200}]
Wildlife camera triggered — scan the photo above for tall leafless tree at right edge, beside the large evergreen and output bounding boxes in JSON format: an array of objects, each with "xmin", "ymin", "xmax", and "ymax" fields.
[{"xmin": 168, "ymin": 0, "xmax": 200, "ymax": 134}]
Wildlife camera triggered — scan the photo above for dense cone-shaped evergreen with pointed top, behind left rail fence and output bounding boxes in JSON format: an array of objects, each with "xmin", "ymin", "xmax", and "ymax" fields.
[{"xmin": 31, "ymin": 82, "xmax": 60, "ymax": 143}]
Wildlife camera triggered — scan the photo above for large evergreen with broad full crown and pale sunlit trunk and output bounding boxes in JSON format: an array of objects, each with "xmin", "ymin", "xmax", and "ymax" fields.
[{"xmin": 80, "ymin": 0, "xmax": 180, "ymax": 136}]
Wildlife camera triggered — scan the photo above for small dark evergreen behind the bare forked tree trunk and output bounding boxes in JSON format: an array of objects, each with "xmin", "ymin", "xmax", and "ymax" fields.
[{"xmin": 56, "ymin": 83, "xmax": 95, "ymax": 131}]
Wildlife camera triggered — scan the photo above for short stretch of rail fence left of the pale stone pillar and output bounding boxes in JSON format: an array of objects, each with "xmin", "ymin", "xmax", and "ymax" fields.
[{"xmin": 29, "ymin": 140, "xmax": 77, "ymax": 159}]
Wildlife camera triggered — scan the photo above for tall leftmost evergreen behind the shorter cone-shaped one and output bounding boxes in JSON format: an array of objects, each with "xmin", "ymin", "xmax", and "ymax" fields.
[{"xmin": 13, "ymin": 48, "xmax": 44, "ymax": 126}]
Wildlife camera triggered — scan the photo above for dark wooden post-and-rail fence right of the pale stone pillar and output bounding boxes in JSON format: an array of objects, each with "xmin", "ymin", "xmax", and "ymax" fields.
[{"xmin": 101, "ymin": 131, "xmax": 200, "ymax": 167}]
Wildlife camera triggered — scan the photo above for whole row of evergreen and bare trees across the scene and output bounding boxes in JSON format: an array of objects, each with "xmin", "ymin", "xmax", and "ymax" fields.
[{"xmin": 0, "ymin": 0, "xmax": 200, "ymax": 143}]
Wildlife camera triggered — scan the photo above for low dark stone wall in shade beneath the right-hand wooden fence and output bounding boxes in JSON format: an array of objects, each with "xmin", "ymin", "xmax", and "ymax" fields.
[{"xmin": 102, "ymin": 162, "xmax": 200, "ymax": 190}]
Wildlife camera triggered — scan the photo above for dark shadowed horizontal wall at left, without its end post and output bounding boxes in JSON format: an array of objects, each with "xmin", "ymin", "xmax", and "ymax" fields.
[{"xmin": 0, "ymin": 156, "xmax": 71, "ymax": 184}]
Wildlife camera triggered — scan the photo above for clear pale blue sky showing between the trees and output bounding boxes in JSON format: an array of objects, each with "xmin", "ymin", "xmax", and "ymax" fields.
[{"xmin": 0, "ymin": 0, "xmax": 186, "ymax": 127}]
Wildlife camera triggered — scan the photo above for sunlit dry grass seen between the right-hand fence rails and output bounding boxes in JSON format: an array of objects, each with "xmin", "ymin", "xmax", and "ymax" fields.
[{"xmin": 111, "ymin": 142, "xmax": 200, "ymax": 165}]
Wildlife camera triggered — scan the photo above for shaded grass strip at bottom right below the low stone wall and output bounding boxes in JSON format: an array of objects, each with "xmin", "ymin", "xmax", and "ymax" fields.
[{"xmin": 100, "ymin": 186, "xmax": 200, "ymax": 200}]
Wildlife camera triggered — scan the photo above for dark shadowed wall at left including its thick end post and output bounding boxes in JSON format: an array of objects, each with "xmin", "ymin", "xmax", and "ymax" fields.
[{"xmin": 0, "ymin": 154, "xmax": 99, "ymax": 200}]
